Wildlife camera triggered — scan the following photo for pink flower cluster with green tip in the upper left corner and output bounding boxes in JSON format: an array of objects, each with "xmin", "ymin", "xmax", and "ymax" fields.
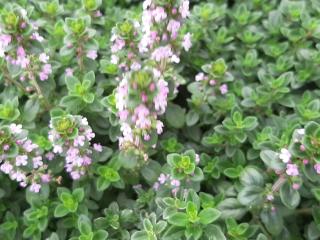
[{"xmin": 0, "ymin": 7, "xmax": 52, "ymax": 91}]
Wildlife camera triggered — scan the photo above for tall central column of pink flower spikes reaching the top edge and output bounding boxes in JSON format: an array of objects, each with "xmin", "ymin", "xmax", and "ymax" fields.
[{"xmin": 111, "ymin": 0, "xmax": 191, "ymax": 159}]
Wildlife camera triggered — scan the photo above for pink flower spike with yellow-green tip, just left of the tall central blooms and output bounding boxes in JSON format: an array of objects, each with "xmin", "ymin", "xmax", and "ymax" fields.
[{"xmin": 49, "ymin": 115, "xmax": 102, "ymax": 179}]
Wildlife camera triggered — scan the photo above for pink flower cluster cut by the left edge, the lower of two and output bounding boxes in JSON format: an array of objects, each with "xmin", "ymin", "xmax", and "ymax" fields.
[{"xmin": 0, "ymin": 123, "xmax": 52, "ymax": 192}]
